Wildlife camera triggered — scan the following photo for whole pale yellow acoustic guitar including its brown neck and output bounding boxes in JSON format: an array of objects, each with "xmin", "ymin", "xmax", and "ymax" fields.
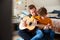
[{"xmin": 21, "ymin": 16, "xmax": 45, "ymax": 30}]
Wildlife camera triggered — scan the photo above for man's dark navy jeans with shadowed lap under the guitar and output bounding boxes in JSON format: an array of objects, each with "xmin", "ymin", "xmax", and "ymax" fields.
[{"xmin": 18, "ymin": 29, "xmax": 33, "ymax": 40}]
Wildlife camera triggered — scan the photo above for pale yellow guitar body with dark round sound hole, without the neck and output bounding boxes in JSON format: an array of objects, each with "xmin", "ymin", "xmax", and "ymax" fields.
[{"xmin": 23, "ymin": 16, "xmax": 35, "ymax": 30}]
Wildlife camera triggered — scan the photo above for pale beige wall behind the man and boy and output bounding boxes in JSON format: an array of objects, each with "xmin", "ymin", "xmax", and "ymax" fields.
[{"xmin": 13, "ymin": 0, "xmax": 60, "ymax": 15}]
